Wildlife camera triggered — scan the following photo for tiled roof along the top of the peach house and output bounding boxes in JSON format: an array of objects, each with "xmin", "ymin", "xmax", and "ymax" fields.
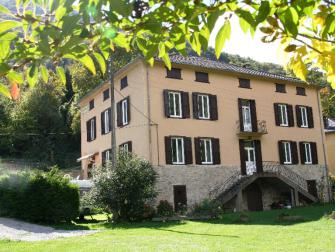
[{"xmin": 156, "ymin": 54, "xmax": 306, "ymax": 84}]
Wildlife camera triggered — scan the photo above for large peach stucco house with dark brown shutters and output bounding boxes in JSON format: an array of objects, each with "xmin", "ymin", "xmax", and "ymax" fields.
[{"xmin": 79, "ymin": 55, "xmax": 330, "ymax": 213}]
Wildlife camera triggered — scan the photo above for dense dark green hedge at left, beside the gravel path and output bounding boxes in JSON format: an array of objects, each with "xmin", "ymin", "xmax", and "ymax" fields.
[{"xmin": 0, "ymin": 169, "xmax": 79, "ymax": 223}]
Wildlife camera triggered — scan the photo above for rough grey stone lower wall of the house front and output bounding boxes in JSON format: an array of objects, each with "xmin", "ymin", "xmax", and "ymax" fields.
[{"xmin": 155, "ymin": 165, "xmax": 328, "ymax": 209}]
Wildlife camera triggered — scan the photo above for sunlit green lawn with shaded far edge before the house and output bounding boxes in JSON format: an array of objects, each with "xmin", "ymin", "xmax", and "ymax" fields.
[{"xmin": 0, "ymin": 204, "xmax": 335, "ymax": 252}]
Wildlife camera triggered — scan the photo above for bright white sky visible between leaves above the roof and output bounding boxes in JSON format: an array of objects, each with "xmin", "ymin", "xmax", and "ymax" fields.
[{"xmin": 209, "ymin": 17, "xmax": 282, "ymax": 64}]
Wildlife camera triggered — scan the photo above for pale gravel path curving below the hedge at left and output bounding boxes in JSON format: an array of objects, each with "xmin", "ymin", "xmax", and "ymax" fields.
[{"xmin": 0, "ymin": 218, "xmax": 98, "ymax": 241}]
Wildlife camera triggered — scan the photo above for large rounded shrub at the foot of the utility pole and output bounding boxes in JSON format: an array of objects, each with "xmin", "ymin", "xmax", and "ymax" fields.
[{"xmin": 89, "ymin": 151, "xmax": 157, "ymax": 221}]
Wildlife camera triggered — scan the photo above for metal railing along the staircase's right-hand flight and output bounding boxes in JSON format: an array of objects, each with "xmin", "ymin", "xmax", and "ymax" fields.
[{"xmin": 263, "ymin": 161, "xmax": 308, "ymax": 191}]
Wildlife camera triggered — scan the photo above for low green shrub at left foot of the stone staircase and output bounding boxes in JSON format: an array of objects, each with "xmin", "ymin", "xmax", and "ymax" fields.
[{"xmin": 191, "ymin": 199, "xmax": 223, "ymax": 218}]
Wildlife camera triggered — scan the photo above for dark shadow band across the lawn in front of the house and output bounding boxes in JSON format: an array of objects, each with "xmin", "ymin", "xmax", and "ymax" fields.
[{"xmin": 54, "ymin": 203, "xmax": 335, "ymax": 231}]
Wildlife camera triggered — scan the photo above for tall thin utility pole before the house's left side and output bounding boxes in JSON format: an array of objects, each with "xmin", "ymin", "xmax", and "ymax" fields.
[{"xmin": 108, "ymin": 51, "xmax": 116, "ymax": 168}]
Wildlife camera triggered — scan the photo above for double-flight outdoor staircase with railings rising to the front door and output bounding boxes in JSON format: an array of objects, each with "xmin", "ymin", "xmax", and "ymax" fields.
[{"xmin": 210, "ymin": 161, "xmax": 318, "ymax": 204}]
